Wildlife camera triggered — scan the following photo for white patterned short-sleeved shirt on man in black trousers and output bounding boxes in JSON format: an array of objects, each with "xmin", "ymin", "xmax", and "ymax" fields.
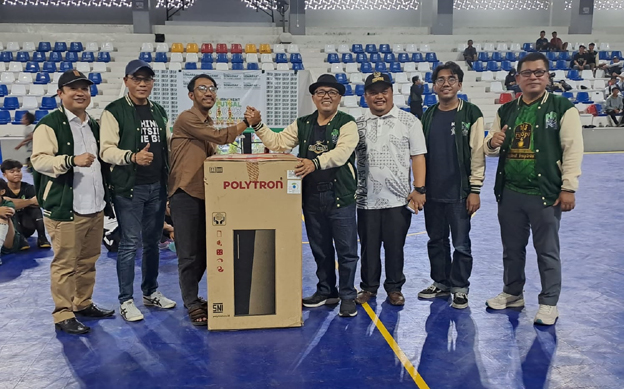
[{"xmin": 355, "ymin": 105, "xmax": 427, "ymax": 209}]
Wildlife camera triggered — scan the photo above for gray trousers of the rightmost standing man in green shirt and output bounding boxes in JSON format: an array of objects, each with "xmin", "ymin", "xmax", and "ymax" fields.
[{"xmin": 498, "ymin": 189, "xmax": 561, "ymax": 305}]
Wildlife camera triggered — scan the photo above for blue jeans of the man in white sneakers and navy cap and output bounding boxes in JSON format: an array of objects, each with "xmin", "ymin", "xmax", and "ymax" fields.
[{"xmin": 114, "ymin": 182, "xmax": 167, "ymax": 303}]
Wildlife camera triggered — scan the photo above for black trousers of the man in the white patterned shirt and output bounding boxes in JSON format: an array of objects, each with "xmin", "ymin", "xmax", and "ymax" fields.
[{"xmin": 358, "ymin": 207, "xmax": 412, "ymax": 293}]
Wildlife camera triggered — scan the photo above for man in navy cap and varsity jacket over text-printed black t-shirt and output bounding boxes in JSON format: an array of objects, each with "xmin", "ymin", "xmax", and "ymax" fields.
[{"xmin": 100, "ymin": 59, "xmax": 176, "ymax": 321}]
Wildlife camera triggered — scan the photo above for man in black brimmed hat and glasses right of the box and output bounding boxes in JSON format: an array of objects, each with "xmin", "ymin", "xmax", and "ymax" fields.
[{"xmin": 245, "ymin": 74, "xmax": 358, "ymax": 317}]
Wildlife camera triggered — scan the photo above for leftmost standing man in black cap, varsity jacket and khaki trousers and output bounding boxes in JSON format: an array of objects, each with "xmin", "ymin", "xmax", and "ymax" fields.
[{"xmin": 31, "ymin": 70, "xmax": 114, "ymax": 334}]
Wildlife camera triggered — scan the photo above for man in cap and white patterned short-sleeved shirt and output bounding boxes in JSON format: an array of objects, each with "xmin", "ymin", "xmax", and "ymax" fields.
[{"xmin": 356, "ymin": 72, "xmax": 427, "ymax": 305}]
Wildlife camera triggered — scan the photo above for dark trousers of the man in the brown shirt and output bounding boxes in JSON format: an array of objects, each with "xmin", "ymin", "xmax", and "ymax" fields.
[{"xmin": 169, "ymin": 189, "xmax": 206, "ymax": 311}]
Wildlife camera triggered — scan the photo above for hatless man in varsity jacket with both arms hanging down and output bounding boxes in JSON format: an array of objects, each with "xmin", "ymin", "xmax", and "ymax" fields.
[{"xmin": 418, "ymin": 62, "xmax": 485, "ymax": 309}]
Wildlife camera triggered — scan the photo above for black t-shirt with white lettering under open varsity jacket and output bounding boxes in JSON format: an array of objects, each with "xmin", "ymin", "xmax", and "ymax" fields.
[{"xmin": 135, "ymin": 104, "xmax": 166, "ymax": 185}]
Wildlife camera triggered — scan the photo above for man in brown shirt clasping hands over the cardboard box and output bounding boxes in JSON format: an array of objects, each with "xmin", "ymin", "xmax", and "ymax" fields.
[{"xmin": 168, "ymin": 74, "xmax": 260, "ymax": 326}]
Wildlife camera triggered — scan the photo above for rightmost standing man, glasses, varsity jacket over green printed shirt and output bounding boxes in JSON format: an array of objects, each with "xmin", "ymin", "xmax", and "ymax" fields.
[{"xmin": 485, "ymin": 53, "xmax": 583, "ymax": 325}]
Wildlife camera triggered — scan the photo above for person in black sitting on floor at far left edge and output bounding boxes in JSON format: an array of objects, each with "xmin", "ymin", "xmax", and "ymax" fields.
[{"xmin": 0, "ymin": 159, "xmax": 50, "ymax": 249}]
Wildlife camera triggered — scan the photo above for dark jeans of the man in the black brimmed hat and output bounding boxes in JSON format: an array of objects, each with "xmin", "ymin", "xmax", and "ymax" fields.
[{"xmin": 303, "ymin": 190, "xmax": 358, "ymax": 300}]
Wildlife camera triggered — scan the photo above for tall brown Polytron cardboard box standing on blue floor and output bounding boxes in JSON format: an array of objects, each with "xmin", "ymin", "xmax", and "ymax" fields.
[{"xmin": 204, "ymin": 154, "xmax": 303, "ymax": 330}]
